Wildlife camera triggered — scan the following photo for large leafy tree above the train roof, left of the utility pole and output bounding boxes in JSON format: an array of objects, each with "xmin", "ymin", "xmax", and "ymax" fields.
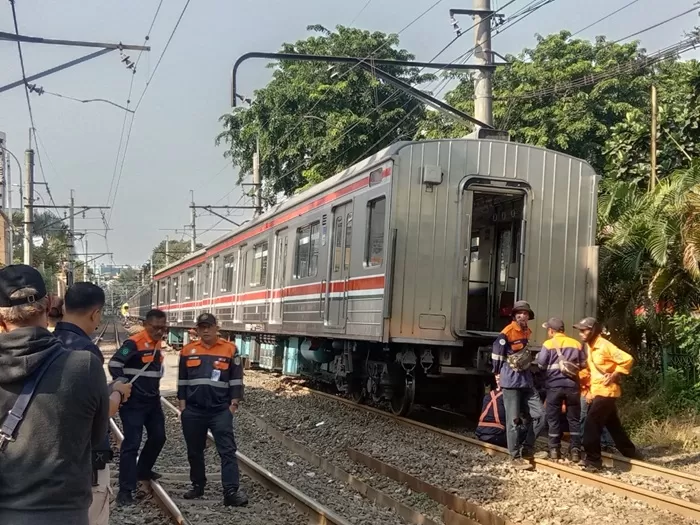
[{"xmin": 216, "ymin": 25, "xmax": 432, "ymax": 200}]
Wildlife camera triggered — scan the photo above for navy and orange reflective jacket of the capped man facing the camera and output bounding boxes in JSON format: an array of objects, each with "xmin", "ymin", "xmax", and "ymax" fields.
[{"xmin": 177, "ymin": 339, "xmax": 243, "ymax": 411}]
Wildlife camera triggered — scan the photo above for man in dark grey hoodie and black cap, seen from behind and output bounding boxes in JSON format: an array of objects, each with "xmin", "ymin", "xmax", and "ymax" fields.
[{"xmin": 0, "ymin": 264, "xmax": 109, "ymax": 525}]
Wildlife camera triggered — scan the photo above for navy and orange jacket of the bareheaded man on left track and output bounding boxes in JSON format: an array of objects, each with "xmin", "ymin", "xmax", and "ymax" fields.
[{"xmin": 108, "ymin": 330, "xmax": 163, "ymax": 403}]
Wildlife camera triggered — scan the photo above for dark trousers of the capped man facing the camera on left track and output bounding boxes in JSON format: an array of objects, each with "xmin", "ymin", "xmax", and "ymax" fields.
[{"xmin": 180, "ymin": 407, "xmax": 239, "ymax": 493}]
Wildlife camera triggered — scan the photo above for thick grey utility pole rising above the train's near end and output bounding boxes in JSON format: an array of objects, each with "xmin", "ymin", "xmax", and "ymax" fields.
[{"xmin": 474, "ymin": 0, "xmax": 493, "ymax": 126}]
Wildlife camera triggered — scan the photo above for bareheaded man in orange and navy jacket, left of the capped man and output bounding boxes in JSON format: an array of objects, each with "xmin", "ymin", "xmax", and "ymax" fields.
[{"xmin": 109, "ymin": 309, "xmax": 168, "ymax": 505}]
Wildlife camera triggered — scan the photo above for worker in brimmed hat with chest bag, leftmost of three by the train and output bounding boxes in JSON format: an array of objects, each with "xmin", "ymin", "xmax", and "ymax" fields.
[{"xmin": 491, "ymin": 301, "xmax": 545, "ymax": 469}]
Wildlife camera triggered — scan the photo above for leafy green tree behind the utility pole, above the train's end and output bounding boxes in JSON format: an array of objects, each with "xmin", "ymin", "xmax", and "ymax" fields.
[{"xmin": 422, "ymin": 31, "xmax": 650, "ymax": 173}]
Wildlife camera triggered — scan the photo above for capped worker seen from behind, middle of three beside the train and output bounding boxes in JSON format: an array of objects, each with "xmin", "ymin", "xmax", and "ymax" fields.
[{"xmin": 537, "ymin": 317, "xmax": 586, "ymax": 463}]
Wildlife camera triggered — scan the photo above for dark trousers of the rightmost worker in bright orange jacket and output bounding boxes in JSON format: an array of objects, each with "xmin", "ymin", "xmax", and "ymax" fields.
[{"xmin": 583, "ymin": 397, "xmax": 637, "ymax": 467}]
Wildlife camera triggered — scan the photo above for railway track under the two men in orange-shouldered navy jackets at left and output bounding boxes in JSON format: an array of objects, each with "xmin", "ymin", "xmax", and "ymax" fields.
[{"xmin": 102, "ymin": 321, "xmax": 352, "ymax": 525}]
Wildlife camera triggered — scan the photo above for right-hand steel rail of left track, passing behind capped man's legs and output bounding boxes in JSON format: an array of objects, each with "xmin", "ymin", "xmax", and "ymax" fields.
[{"xmin": 160, "ymin": 397, "xmax": 352, "ymax": 525}]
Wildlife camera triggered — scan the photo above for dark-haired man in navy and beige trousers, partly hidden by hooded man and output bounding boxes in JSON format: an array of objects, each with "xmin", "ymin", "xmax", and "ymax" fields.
[{"xmin": 53, "ymin": 283, "xmax": 131, "ymax": 525}]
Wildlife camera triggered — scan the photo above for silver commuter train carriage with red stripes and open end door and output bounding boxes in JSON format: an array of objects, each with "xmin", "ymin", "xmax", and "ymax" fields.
[{"xmin": 129, "ymin": 139, "xmax": 598, "ymax": 414}]
